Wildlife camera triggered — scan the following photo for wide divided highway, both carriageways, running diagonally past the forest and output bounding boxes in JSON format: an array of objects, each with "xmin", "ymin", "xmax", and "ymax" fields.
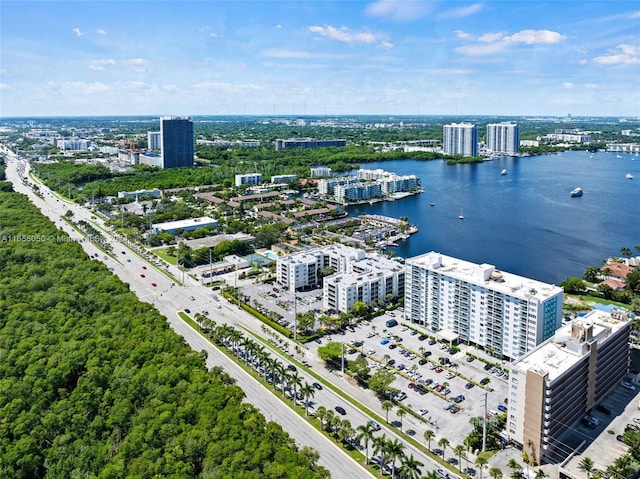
[{"xmin": 7, "ymin": 148, "xmax": 464, "ymax": 478}]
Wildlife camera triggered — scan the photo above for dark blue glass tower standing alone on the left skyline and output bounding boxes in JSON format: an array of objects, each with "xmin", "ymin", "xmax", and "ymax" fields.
[{"xmin": 160, "ymin": 116, "xmax": 194, "ymax": 168}]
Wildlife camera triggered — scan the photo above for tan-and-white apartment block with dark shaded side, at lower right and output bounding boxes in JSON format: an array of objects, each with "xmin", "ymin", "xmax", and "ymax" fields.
[{"xmin": 507, "ymin": 309, "xmax": 632, "ymax": 464}]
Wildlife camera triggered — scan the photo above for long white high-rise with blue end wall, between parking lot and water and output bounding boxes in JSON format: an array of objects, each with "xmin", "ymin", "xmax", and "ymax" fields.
[{"xmin": 404, "ymin": 251, "xmax": 563, "ymax": 359}]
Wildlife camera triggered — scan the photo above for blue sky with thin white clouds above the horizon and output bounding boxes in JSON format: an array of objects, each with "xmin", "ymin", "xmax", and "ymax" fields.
[{"xmin": 0, "ymin": 0, "xmax": 640, "ymax": 117}]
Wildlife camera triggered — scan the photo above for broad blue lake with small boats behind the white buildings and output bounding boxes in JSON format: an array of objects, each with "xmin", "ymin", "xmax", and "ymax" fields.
[{"xmin": 349, "ymin": 152, "xmax": 640, "ymax": 284}]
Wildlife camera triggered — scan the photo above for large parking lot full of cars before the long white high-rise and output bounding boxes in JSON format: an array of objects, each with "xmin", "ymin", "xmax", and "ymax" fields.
[{"xmin": 307, "ymin": 311, "xmax": 507, "ymax": 441}]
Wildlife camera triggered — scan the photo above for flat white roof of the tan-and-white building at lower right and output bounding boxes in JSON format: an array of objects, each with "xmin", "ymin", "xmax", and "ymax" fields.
[{"xmin": 513, "ymin": 309, "xmax": 631, "ymax": 381}]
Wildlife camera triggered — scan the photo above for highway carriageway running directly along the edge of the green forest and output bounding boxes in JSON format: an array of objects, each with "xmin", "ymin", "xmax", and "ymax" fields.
[{"xmin": 6, "ymin": 157, "xmax": 371, "ymax": 478}]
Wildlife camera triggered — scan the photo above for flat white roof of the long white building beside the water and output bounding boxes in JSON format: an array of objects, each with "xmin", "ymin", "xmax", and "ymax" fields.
[{"xmin": 407, "ymin": 251, "xmax": 563, "ymax": 300}]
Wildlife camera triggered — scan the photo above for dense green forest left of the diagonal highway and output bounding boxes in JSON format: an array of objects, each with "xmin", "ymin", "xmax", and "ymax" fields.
[{"xmin": 0, "ymin": 192, "xmax": 328, "ymax": 479}]
